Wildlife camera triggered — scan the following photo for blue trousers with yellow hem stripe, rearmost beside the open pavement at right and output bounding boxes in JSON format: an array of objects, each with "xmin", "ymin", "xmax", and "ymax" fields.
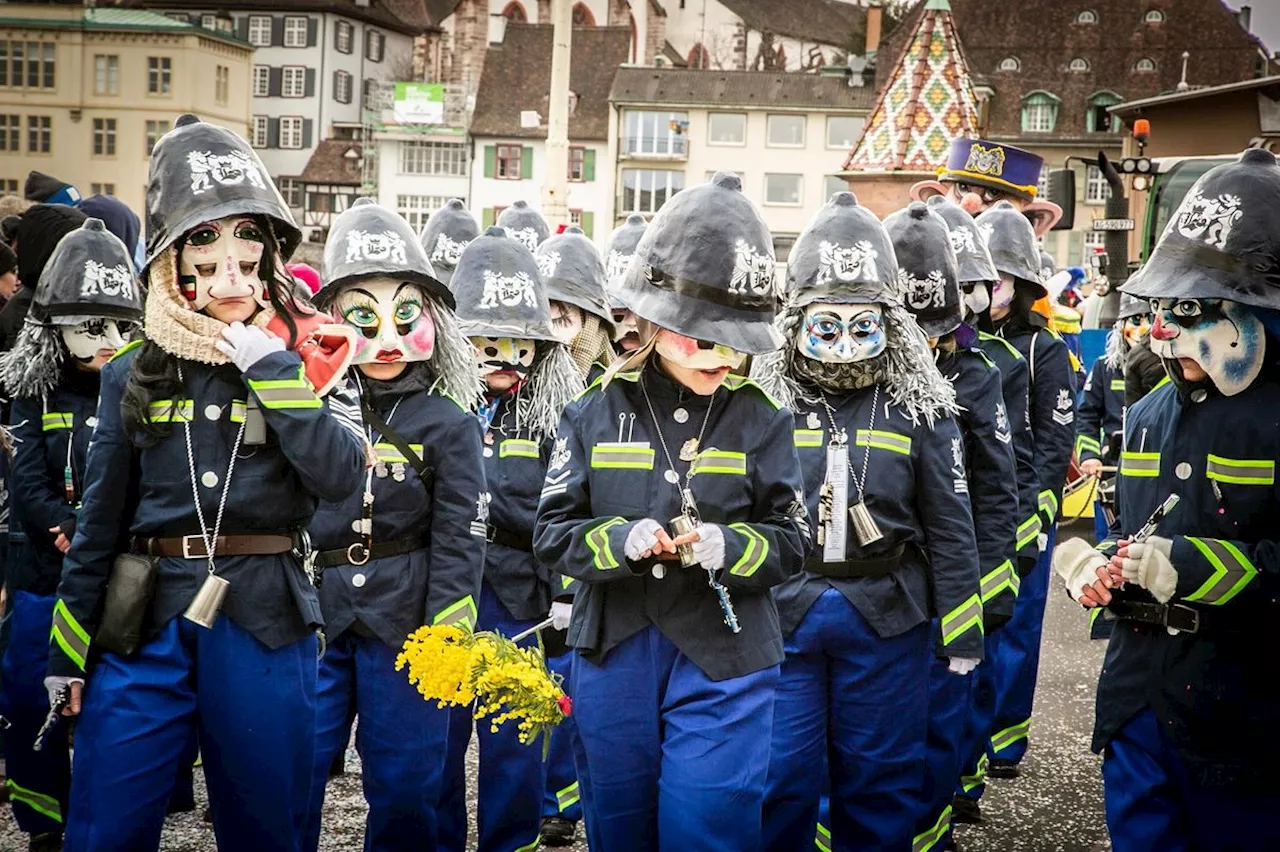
[{"xmin": 983, "ymin": 526, "xmax": 1057, "ymax": 764}]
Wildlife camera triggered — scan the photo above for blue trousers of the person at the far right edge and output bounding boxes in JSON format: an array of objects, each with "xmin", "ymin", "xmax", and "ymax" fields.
[{"xmin": 1102, "ymin": 710, "xmax": 1280, "ymax": 852}]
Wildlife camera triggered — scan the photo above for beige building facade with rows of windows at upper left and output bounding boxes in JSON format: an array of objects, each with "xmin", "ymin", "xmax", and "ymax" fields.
[{"xmin": 0, "ymin": 3, "xmax": 253, "ymax": 215}]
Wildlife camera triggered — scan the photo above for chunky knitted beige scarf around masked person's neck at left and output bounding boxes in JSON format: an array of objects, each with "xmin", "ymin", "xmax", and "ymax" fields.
[{"xmin": 145, "ymin": 246, "xmax": 279, "ymax": 366}]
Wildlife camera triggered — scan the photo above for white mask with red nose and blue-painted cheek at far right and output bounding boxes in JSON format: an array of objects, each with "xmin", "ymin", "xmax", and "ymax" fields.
[{"xmin": 1151, "ymin": 299, "xmax": 1266, "ymax": 397}]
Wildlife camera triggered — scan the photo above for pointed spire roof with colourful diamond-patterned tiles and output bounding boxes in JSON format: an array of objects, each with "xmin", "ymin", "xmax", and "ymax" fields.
[{"xmin": 845, "ymin": 0, "xmax": 978, "ymax": 171}]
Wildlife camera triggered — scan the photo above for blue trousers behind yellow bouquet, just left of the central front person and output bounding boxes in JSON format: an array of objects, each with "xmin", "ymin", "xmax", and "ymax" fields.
[{"xmin": 436, "ymin": 581, "xmax": 547, "ymax": 852}]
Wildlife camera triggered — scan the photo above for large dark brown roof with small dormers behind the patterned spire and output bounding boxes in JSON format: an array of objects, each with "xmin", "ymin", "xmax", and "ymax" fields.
[{"xmin": 877, "ymin": 0, "xmax": 1262, "ymax": 145}]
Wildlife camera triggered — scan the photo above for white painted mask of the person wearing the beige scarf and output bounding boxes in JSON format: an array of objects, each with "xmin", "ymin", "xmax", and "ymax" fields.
[{"xmin": 178, "ymin": 215, "xmax": 270, "ymax": 311}]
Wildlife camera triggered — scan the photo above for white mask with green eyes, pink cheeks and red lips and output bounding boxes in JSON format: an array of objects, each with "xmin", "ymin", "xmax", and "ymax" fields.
[{"xmin": 334, "ymin": 278, "xmax": 435, "ymax": 365}]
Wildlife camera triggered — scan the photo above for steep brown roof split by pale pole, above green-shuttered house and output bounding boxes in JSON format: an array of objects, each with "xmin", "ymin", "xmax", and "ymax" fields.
[{"xmin": 471, "ymin": 23, "xmax": 631, "ymax": 139}]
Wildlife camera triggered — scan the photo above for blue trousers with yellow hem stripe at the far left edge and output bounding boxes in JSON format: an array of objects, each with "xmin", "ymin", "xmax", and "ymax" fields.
[{"xmin": 3, "ymin": 591, "xmax": 72, "ymax": 834}]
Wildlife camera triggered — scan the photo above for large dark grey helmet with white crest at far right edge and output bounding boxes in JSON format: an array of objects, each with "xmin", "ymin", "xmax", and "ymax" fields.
[{"xmin": 1121, "ymin": 148, "xmax": 1280, "ymax": 310}]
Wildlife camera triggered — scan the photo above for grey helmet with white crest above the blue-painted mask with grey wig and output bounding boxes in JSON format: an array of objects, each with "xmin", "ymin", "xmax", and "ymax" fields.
[{"xmin": 786, "ymin": 192, "xmax": 897, "ymax": 308}]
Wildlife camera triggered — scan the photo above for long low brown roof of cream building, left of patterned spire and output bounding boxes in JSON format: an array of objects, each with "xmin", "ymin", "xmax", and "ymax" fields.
[{"xmin": 609, "ymin": 67, "xmax": 874, "ymax": 110}]
